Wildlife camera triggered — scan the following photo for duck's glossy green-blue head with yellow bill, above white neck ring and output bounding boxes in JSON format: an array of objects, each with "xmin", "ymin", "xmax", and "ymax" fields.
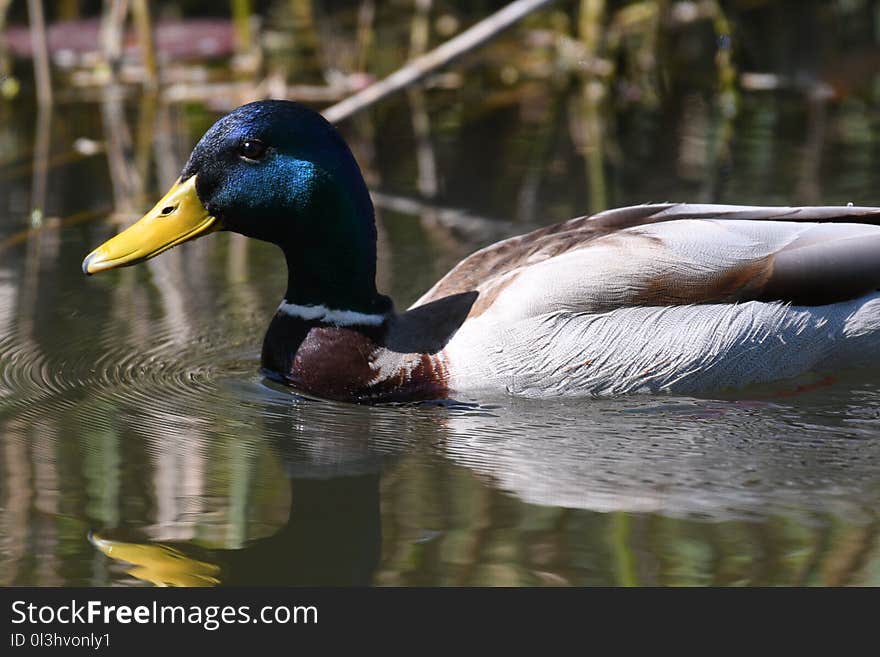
[{"xmin": 83, "ymin": 100, "xmax": 387, "ymax": 312}]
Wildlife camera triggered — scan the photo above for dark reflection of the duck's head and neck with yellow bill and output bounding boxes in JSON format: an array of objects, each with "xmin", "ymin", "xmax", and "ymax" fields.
[{"xmin": 90, "ymin": 390, "xmax": 407, "ymax": 586}]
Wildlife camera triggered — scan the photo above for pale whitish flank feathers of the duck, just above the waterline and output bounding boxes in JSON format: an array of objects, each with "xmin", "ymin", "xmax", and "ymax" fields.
[{"xmin": 446, "ymin": 288, "xmax": 880, "ymax": 398}]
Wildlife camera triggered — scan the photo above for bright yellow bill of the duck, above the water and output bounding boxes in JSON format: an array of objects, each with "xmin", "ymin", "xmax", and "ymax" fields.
[{"xmin": 83, "ymin": 176, "xmax": 219, "ymax": 274}]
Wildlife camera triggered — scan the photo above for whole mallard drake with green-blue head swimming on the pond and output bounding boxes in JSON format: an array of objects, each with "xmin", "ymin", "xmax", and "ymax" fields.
[{"xmin": 83, "ymin": 100, "xmax": 880, "ymax": 403}]
